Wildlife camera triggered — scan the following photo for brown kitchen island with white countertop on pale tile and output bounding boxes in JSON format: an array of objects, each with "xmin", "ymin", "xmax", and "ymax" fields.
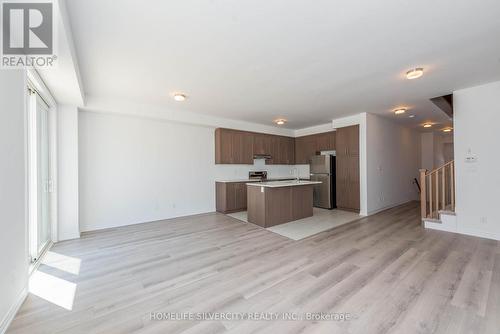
[{"xmin": 247, "ymin": 180, "xmax": 321, "ymax": 227}]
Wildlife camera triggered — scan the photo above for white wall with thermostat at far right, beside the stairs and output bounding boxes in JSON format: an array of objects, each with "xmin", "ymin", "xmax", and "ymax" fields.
[{"xmin": 453, "ymin": 82, "xmax": 500, "ymax": 240}]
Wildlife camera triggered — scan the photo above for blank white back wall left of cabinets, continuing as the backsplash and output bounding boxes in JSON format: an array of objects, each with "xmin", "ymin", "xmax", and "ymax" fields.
[{"xmin": 79, "ymin": 111, "xmax": 309, "ymax": 231}]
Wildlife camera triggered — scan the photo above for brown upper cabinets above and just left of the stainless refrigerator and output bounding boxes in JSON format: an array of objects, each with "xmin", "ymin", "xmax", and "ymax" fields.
[{"xmin": 295, "ymin": 131, "xmax": 336, "ymax": 164}]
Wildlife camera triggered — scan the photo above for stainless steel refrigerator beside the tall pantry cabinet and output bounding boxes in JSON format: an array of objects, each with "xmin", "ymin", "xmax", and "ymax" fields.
[{"xmin": 310, "ymin": 155, "xmax": 337, "ymax": 209}]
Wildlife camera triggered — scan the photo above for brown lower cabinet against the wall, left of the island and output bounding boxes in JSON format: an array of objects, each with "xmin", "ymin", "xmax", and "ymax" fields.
[{"xmin": 215, "ymin": 182, "xmax": 252, "ymax": 213}]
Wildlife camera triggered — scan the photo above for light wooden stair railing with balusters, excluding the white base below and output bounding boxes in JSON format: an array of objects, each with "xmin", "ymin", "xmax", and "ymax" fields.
[{"xmin": 420, "ymin": 160, "xmax": 455, "ymax": 219}]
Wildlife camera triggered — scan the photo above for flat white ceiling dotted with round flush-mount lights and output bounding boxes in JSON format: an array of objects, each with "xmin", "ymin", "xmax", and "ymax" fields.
[{"xmin": 67, "ymin": 0, "xmax": 500, "ymax": 129}]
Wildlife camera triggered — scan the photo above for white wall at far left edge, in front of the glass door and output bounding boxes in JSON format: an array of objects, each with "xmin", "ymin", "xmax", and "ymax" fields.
[{"xmin": 0, "ymin": 70, "xmax": 29, "ymax": 333}]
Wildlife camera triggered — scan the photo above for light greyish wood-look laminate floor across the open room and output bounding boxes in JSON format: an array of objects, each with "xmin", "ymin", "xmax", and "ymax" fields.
[{"xmin": 8, "ymin": 203, "xmax": 500, "ymax": 334}]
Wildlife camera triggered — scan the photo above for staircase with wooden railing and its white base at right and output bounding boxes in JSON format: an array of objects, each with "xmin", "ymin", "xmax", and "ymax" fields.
[{"xmin": 420, "ymin": 160, "xmax": 457, "ymax": 232}]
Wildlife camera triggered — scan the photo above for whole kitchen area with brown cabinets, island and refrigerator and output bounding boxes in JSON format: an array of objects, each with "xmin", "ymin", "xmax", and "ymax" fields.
[{"xmin": 215, "ymin": 125, "xmax": 360, "ymax": 236}]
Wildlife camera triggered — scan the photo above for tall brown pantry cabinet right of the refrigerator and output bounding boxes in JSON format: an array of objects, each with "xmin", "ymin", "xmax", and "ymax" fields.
[{"xmin": 335, "ymin": 125, "xmax": 360, "ymax": 212}]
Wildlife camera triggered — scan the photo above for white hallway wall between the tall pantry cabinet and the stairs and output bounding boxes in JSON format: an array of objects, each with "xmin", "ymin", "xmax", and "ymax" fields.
[{"xmin": 366, "ymin": 114, "xmax": 420, "ymax": 214}]
